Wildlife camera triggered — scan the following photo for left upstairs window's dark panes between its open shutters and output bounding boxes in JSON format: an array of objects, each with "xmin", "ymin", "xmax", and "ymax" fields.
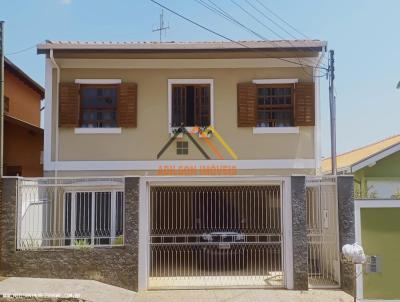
[{"xmin": 80, "ymin": 85, "xmax": 118, "ymax": 128}]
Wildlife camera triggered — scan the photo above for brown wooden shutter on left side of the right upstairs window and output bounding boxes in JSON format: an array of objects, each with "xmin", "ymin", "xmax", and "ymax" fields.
[{"xmin": 237, "ymin": 83, "xmax": 257, "ymax": 127}]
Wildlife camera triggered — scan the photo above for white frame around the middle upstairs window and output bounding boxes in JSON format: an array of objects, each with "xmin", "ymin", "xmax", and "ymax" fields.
[{"xmin": 168, "ymin": 79, "xmax": 214, "ymax": 134}]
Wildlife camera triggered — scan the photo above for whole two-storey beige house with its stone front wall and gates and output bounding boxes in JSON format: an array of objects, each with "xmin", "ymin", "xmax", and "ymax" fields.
[{"xmin": 0, "ymin": 40, "xmax": 354, "ymax": 290}]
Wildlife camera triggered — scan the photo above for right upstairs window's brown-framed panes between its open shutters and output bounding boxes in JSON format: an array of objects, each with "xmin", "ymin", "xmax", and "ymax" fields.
[{"xmin": 256, "ymin": 85, "xmax": 294, "ymax": 127}]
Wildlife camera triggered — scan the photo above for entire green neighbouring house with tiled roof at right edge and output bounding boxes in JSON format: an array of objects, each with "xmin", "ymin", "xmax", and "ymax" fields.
[{"xmin": 322, "ymin": 135, "xmax": 400, "ymax": 301}]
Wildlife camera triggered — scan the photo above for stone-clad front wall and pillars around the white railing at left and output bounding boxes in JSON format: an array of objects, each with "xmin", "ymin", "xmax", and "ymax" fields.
[{"xmin": 0, "ymin": 177, "xmax": 139, "ymax": 290}]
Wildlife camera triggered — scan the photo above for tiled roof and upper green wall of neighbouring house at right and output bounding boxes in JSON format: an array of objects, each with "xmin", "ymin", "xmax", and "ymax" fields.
[{"xmin": 322, "ymin": 135, "xmax": 400, "ymax": 199}]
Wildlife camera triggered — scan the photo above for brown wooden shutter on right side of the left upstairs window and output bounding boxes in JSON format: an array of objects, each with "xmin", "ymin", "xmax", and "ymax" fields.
[{"xmin": 117, "ymin": 83, "xmax": 137, "ymax": 128}]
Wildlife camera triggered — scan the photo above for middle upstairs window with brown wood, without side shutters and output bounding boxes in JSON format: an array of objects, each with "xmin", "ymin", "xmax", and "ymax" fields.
[{"xmin": 171, "ymin": 84, "xmax": 211, "ymax": 128}]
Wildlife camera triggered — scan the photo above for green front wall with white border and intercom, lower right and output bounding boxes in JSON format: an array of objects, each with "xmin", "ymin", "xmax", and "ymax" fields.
[{"xmin": 354, "ymin": 199, "xmax": 400, "ymax": 301}]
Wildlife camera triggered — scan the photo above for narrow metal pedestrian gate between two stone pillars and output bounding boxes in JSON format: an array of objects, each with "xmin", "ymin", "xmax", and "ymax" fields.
[{"xmin": 306, "ymin": 176, "xmax": 340, "ymax": 288}]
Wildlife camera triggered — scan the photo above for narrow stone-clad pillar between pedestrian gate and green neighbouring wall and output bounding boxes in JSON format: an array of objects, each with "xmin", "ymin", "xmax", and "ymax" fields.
[{"xmin": 337, "ymin": 176, "xmax": 356, "ymax": 295}]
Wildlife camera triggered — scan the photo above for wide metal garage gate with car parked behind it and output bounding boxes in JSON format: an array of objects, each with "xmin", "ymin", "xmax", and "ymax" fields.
[{"xmin": 149, "ymin": 185, "xmax": 284, "ymax": 288}]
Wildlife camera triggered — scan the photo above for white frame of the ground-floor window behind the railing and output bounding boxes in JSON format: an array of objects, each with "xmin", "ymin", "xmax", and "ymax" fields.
[{"xmin": 63, "ymin": 188, "xmax": 125, "ymax": 248}]
